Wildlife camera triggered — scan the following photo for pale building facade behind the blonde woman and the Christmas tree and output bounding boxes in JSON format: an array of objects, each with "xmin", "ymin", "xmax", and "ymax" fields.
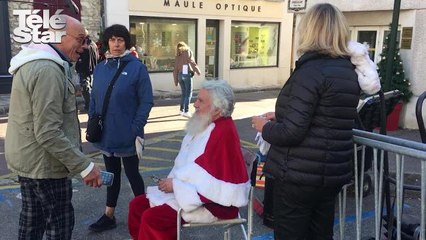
[{"xmin": 293, "ymin": 0, "xmax": 426, "ymax": 129}]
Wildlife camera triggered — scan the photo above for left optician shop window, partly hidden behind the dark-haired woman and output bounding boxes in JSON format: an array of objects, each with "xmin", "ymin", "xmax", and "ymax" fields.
[{"xmin": 130, "ymin": 16, "xmax": 196, "ymax": 72}]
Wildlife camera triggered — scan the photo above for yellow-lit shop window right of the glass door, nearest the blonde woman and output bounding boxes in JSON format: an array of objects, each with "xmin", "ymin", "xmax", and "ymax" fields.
[{"xmin": 230, "ymin": 21, "xmax": 279, "ymax": 68}]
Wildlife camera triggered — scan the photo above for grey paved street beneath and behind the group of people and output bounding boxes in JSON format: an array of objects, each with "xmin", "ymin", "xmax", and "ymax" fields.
[{"xmin": 0, "ymin": 90, "xmax": 420, "ymax": 240}]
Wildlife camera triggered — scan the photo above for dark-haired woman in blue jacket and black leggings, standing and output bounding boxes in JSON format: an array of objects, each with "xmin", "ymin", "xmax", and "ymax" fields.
[{"xmin": 89, "ymin": 24, "xmax": 153, "ymax": 232}]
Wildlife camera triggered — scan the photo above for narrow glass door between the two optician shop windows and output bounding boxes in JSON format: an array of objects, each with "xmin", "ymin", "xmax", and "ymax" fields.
[{"xmin": 205, "ymin": 20, "xmax": 219, "ymax": 79}]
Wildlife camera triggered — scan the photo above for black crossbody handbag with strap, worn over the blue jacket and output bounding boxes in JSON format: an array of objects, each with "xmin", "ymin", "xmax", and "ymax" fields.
[{"xmin": 86, "ymin": 62, "xmax": 128, "ymax": 143}]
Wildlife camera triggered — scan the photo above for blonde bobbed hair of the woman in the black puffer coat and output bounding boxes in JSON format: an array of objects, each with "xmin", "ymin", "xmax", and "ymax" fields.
[{"xmin": 297, "ymin": 3, "xmax": 349, "ymax": 57}]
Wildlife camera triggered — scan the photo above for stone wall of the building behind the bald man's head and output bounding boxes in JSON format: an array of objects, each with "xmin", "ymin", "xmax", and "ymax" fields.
[{"xmin": 8, "ymin": 0, "xmax": 103, "ymax": 56}]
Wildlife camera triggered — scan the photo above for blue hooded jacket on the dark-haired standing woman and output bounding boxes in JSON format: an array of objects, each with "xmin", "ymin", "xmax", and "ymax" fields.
[{"xmin": 89, "ymin": 54, "xmax": 153, "ymax": 155}]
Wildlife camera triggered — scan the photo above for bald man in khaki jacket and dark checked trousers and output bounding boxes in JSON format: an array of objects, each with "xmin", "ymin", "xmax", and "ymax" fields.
[{"xmin": 5, "ymin": 16, "xmax": 102, "ymax": 239}]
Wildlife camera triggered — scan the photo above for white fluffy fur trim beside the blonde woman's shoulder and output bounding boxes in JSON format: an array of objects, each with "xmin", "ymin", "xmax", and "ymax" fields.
[{"xmin": 348, "ymin": 41, "xmax": 381, "ymax": 95}]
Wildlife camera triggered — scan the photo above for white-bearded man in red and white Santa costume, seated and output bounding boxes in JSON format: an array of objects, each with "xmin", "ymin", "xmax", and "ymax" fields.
[{"xmin": 128, "ymin": 80, "xmax": 250, "ymax": 240}]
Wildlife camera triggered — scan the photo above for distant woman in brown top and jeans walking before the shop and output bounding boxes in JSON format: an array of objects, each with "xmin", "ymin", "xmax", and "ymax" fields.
[{"xmin": 173, "ymin": 42, "xmax": 200, "ymax": 118}]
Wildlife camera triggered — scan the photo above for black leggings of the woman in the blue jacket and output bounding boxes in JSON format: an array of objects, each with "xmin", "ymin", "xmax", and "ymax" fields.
[{"xmin": 103, "ymin": 155, "xmax": 145, "ymax": 207}]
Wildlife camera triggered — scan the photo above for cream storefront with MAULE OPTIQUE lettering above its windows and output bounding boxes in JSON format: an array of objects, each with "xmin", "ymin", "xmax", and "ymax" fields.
[{"xmin": 105, "ymin": 0, "xmax": 293, "ymax": 95}]
